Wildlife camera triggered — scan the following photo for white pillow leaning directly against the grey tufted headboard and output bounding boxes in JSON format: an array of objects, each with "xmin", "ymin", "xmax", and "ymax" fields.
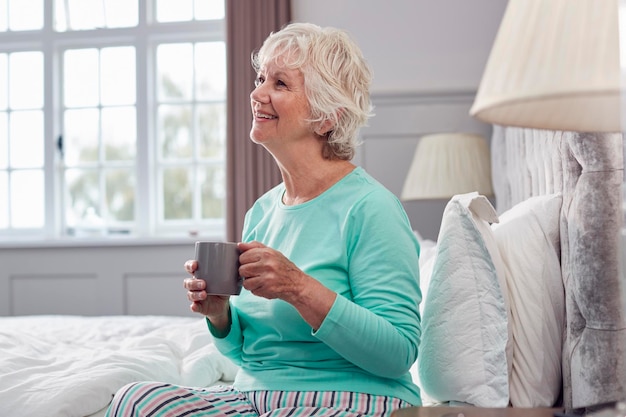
[{"xmin": 491, "ymin": 194, "xmax": 565, "ymax": 407}]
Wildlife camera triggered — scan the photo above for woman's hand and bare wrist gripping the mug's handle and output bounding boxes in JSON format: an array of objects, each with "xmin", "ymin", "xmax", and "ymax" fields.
[{"xmin": 237, "ymin": 242, "xmax": 337, "ymax": 329}]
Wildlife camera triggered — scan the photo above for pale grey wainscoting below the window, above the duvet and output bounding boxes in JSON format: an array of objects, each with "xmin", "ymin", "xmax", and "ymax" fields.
[{"xmin": 0, "ymin": 240, "xmax": 194, "ymax": 316}]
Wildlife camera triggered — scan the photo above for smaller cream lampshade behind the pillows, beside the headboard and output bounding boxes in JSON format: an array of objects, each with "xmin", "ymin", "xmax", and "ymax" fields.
[{"xmin": 400, "ymin": 133, "xmax": 493, "ymax": 200}]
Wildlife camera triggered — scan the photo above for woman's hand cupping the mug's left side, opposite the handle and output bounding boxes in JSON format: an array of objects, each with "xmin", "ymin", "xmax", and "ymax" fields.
[{"xmin": 183, "ymin": 260, "xmax": 230, "ymax": 329}]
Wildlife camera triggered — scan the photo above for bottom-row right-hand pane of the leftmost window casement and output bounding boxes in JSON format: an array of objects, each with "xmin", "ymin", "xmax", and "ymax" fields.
[{"xmin": 10, "ymin": 170, "xmax": 45, "ymax": 228}]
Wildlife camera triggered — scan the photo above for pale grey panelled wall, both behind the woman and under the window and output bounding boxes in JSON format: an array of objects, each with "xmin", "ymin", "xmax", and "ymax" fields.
[{"xmin": 0, "ymin": 0, "xmax": 506, "ymax": 316}]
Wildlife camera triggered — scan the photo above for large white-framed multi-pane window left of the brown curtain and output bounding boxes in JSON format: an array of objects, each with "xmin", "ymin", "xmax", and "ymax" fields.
[{"xmin": 0, "ymin": 0, "xmax": 226, "ymax": 239}]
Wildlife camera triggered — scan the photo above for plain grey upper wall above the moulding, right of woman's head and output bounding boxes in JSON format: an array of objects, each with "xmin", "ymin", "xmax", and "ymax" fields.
[{"xmin": 292, "ymin": 0, "xmax": 507, "ymax": 93}]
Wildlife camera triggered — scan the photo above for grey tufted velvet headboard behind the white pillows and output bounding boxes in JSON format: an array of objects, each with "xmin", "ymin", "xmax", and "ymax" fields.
[{"xmin": 491, "ymin": 126, "xmax": 626, "ymax": 408}]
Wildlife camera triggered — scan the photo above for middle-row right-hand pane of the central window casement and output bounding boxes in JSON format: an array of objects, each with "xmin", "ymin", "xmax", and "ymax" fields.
[{"xmin": 102, "ymin": 107, "xmax": 137, "ymax": 161}]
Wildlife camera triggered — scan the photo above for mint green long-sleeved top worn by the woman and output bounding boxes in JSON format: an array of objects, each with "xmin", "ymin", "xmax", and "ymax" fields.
[{"xmin": 209, "ymin": 167, "xmax": 422, "ymax": 405}]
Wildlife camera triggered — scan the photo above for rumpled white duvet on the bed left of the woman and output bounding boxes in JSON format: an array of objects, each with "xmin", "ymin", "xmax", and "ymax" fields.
[{"xmin": 0, "ymin": 316, "xmax": 236, "ymax": 417}]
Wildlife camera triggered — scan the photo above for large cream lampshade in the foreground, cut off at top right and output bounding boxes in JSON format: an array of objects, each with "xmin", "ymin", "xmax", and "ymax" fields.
[{"xmin": 470, "ymin": 0, "xmax": 623, "ymax": 132}]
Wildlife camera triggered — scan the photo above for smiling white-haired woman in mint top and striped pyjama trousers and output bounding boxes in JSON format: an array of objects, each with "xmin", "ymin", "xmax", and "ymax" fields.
[{"xmin": 108, "ymin": 23, "xmax": 421, "ymax": 416}]
